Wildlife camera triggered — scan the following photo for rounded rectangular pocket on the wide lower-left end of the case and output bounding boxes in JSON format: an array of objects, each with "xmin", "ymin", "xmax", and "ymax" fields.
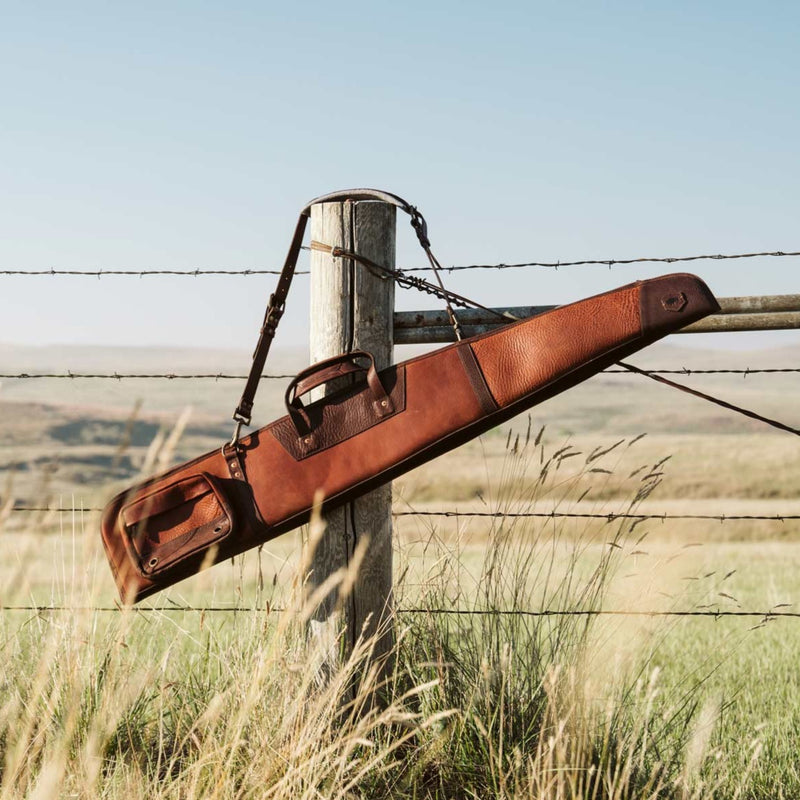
[{"xmin": 122, "ymin": 472, "xmax": 233, "ymax": 577}]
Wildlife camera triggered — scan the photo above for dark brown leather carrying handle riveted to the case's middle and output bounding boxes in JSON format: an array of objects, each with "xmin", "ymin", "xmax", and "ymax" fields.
[{"xmin": 284, "ymin": 350, "xmax": 394, "ymax": 438}]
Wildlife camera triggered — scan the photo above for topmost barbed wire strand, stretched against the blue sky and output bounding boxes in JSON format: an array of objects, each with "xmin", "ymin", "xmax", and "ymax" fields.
[{"xmin": 0, "ymin": 247, "xmax": 800, "ymax": 278}]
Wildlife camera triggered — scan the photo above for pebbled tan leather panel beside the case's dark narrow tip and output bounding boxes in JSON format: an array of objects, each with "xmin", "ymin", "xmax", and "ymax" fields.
[{"xmin": 471, "ymin": 285, "xmax": 641, "ymax": 406}]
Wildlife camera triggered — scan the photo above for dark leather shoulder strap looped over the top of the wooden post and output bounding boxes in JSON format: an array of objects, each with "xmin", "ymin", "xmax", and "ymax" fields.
[{"xmin": 231, "ymin": 189, "xmax": 438, "ymax": 424}]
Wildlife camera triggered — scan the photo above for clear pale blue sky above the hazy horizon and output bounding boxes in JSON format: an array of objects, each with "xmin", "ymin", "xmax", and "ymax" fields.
[{"xmin": 0, "ymin": 0, "xmax": 800, "ymax": 348}]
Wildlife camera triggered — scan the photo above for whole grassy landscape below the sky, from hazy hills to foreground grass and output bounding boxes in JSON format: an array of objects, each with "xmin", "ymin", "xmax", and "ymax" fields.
[{"xmin": 0, "ymin": 340, "xmax": 800, "ymax": 798}]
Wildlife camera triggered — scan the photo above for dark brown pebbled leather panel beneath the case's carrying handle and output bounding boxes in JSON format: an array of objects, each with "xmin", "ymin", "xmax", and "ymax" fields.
[{"xmin": 268, "ymin": 366, "xmax": 406, "ymax": 461}]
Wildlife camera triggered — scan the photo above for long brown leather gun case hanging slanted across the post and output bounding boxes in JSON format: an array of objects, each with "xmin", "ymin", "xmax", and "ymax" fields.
[{"xmin": 102, "ymin": 274, "xmax": 719, "ymax": 602}]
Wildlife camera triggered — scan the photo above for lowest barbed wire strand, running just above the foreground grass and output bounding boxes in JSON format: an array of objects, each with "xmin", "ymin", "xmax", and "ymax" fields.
[{"xmin": 0, "ymin": 603, "xmax": 800, "ymax": 622}]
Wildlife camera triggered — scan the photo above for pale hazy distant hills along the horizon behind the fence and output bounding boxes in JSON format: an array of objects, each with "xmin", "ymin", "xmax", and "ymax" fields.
[{"xmin": 0, "ymin": 338, "xmax": 800, "ymax": 432}]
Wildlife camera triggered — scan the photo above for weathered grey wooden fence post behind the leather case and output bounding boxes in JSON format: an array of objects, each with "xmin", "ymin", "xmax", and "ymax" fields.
[{"xmin": 310, "ymin": 201, "xmax": 396, "ymax": 671}]
